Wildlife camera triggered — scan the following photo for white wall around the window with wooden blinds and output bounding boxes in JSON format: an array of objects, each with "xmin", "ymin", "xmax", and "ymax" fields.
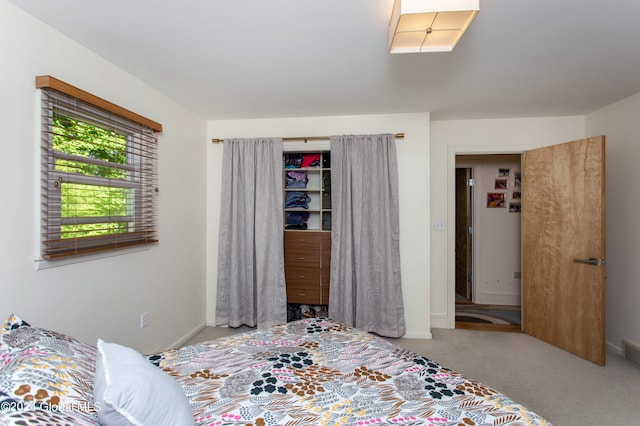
[{"xmin": 0, "ymin": 0, "xmax": 206, "ymax": 352}]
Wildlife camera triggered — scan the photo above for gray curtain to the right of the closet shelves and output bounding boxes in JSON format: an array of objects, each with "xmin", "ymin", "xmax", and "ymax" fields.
[{"xmin": 329, "ymin": 135, "xmax": 405, "ymax": 337}]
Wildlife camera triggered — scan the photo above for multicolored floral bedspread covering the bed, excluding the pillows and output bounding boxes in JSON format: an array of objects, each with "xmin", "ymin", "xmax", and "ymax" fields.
[{"xmin": 148, "ymin": 318, "xmax": 549, "ymax": 426}]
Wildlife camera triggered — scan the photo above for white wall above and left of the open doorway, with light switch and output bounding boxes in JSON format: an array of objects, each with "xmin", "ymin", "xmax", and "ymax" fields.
[{"xmin": 429, "ymin": 117, "xmax": 584, "ymax": 328}]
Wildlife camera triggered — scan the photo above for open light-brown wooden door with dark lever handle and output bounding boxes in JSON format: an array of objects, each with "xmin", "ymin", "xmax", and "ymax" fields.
[{"xmin": 522, "ymin": 136, "xmax": 605, "ymax": 365}]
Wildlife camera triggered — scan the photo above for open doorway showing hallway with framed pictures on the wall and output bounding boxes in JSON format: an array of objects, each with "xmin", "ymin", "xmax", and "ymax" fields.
[{"xmin": 455, "ymin": 154, "xmax": 522, "ymax": 332}]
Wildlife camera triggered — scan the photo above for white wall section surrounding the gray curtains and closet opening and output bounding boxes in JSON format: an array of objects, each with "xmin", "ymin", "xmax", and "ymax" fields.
[{"xmin": 207, "ymin": 113, "xmax": 431, "ymax": 338}]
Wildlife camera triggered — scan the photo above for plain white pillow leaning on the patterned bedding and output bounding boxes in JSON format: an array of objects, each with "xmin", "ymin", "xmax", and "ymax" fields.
[{"xmin": 93, "ymin": 340, "xmax": 195, "ymax": 426}]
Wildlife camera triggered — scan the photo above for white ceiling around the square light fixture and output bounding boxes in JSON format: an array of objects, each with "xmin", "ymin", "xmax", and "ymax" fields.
[{"xmin": 10, "ymin": 0, "xmax": 640, "ymax": 120}]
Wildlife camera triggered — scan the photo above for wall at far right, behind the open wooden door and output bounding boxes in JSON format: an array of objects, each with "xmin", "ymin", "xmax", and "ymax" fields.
[{"xmin": 586, "ymin": 93, "xmax": 640, "ymax": 352}]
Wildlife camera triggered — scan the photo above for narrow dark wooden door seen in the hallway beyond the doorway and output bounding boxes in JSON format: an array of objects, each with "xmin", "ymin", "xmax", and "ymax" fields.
[{"xmin": 456, "ymin": 168, "xmax": 471, "ymax": 302}]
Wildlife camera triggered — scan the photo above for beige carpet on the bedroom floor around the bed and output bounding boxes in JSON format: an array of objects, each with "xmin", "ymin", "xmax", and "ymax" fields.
[{"xmin": 189, "ymin": 327, "xmax": 640, "ymax": 426}]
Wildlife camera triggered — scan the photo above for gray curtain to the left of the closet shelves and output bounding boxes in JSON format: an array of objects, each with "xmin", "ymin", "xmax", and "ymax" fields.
[{"xmin": 216, "ymin": 138, "xmax": 287, "ymax": 328}]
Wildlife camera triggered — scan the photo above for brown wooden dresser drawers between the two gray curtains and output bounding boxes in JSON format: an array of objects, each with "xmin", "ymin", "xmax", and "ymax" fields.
[{"xmin": 284, "ymin": 231, "xmax": 331, "ymax": 305}]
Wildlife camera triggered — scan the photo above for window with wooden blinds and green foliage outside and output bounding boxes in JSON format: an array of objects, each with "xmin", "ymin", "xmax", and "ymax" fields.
[{"xmin": 36, "ymin": 76, "xmax": 162, "ymax": 259}]
